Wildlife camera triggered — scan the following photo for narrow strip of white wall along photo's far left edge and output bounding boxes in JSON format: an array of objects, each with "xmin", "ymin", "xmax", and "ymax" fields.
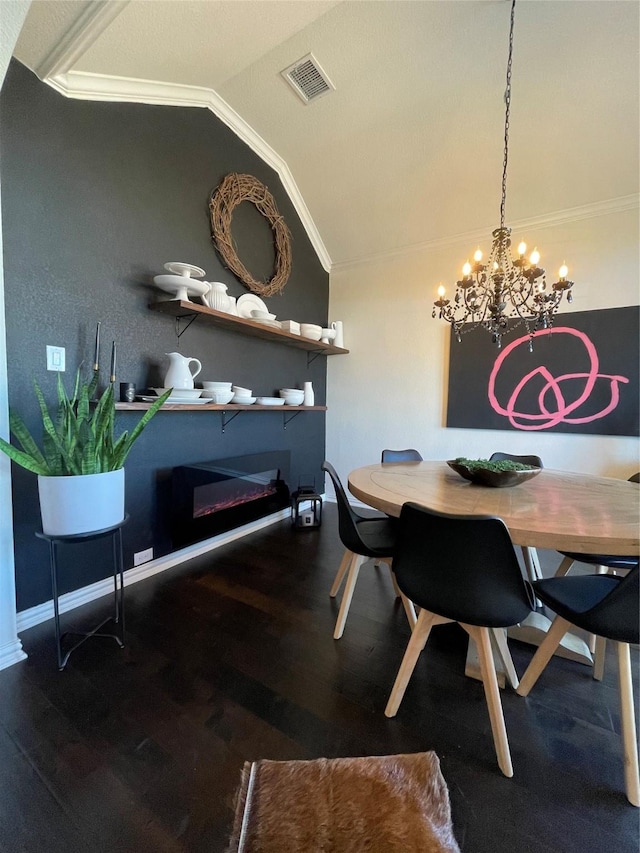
[{"xmin": 0, "ymin": 0, "xmax": 30, "ymax": 669}]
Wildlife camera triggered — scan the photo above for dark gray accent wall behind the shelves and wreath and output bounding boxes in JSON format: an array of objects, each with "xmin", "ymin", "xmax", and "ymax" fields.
[{"xmin": 0, "ymin": 60, "xmax": 329, "ymax": 610}]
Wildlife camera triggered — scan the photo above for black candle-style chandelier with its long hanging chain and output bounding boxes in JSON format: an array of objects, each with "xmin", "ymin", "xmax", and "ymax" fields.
[{"xmin": 431, "ymin": 0, "xmax": 573, "ymax": 351}]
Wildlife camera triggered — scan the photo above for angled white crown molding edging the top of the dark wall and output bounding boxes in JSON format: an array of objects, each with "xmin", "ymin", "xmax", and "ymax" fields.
[{"xmin": 44, "ymin": 70, "xmax": 332, "ymax": 272}]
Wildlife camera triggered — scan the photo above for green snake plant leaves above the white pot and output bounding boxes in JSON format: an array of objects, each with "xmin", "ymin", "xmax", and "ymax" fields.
[{"xmin": 0, "ymin": 370, "xmax": 171, "ymax": 477}]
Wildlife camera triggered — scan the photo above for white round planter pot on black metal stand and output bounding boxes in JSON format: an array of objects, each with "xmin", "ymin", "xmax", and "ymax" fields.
[{"xmin": 38, "ymin": 468, "xmax": 124, "ymax": 536}]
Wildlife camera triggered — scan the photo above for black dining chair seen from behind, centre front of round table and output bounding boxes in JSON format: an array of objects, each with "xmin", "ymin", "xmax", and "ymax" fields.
[{"xmin": 385, "ymin": 502, "xmax": 533, "ymax": 776}]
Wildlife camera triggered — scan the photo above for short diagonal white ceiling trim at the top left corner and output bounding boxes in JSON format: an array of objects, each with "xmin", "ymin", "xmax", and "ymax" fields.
[{"xmin": 34, "ymin": 0, "xmax": 129, "ymax": 79}]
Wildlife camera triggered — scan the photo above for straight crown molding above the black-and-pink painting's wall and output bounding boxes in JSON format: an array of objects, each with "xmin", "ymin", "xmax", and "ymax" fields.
[{"xmin": 331, "ymin": 193, "xmax": 640, "ymax": 273}]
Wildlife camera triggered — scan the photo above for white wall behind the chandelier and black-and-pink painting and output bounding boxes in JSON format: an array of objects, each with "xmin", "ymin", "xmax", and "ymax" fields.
[{"xmin": 327, "ymin": 207, "xmax": 640, "ymax": 488}]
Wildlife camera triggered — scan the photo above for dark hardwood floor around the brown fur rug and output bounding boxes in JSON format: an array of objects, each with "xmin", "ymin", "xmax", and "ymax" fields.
[{"xmin": 0, "ymin": 505, "xmax": 638, "ymax": 853}]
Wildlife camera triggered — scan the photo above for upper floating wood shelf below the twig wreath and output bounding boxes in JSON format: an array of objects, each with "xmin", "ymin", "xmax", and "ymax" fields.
[{"xmin": 149, "ymin": 299, "xmax": 349, "ymax": 354}]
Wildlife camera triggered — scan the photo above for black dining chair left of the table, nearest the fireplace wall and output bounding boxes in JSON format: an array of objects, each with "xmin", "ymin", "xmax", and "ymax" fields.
[{"xmin": 321, "ymin": 462, "xmax": 416, "ymax": 640}]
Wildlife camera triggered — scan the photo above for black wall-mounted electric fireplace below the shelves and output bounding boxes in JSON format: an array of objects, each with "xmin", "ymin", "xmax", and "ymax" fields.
[{"xmin": 171, "ymin": 451, "xmax": 290, "ymax": 548}]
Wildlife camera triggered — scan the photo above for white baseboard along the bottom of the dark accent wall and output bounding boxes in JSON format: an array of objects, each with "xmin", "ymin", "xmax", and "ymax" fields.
[{"xmin": 15, "ymin": 507, "xmax": 291, "ymax": 632}]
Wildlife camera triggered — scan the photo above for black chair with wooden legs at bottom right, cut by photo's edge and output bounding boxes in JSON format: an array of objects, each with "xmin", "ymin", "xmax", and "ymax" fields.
[{"xmin": 516, "ymin": 566, "xmax": 640, "ymax": 806}]
